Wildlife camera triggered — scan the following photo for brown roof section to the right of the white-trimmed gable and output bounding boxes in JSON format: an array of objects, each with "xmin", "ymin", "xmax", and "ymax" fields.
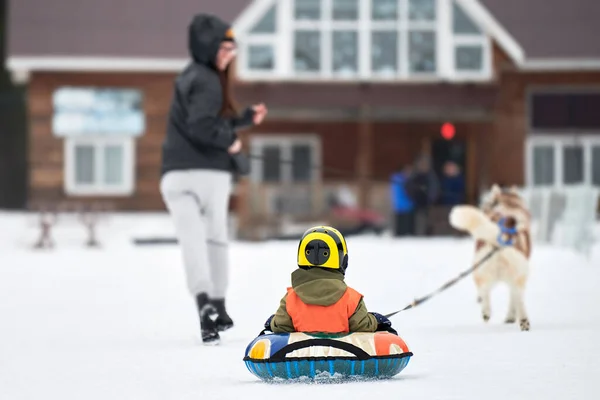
[{"xmin": 479, "ymin": 0, "xmax": 600, "ymax": 62}]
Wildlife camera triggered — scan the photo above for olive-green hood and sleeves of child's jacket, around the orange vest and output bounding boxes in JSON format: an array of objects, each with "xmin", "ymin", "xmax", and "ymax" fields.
[{"xmin": 271, "ymin": 268, "xmax": 377, "ymax": 333}]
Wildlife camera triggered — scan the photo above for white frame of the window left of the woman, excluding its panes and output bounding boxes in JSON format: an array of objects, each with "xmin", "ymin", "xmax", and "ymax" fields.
[{"xmin": 64, "ymin": 135, "xmax": 135, "ymax": 196}]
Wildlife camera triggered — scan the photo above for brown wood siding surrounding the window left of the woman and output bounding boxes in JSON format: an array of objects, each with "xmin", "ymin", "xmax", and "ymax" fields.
[{"xmin": 28, "ymin": 73, "xmax": 174, "ymax": 210}]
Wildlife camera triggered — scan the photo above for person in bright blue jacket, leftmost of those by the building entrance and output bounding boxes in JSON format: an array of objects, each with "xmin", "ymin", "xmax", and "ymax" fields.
[{"xmin": 391, "ymin": 165, "xmax": 415, "ymax": 236}]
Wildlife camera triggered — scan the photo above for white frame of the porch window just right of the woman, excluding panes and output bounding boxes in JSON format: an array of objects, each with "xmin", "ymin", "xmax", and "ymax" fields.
[{"xmin": 250, "ymin": 133, "xmax": 322, "ymax": 185}]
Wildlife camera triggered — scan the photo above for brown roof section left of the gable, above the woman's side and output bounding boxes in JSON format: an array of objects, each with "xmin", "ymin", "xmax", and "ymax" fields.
[{"xmin": 8, "ymin": 0, "xmax": 252, "ymax": 59}]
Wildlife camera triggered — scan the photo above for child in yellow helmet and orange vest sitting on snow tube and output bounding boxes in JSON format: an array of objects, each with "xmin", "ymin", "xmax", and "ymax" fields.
[{"xmin": 264, "ymin": 226, "xmax": 398, "ymax": 335}]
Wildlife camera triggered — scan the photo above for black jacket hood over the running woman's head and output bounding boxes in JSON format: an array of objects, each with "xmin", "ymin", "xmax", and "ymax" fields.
[{"xmin": 188, "ymin": 14, "xmax": 233, "ymax": 68}]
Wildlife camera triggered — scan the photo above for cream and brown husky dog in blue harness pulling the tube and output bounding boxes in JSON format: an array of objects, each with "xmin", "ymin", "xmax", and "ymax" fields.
[{"xmin": 450, "ymin": 185, "xmax": 531, "ymax": 331}]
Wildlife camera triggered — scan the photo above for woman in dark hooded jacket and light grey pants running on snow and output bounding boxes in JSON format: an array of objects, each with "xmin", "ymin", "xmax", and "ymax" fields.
[{"xmin": 160, "ymin": 14, "xmax": 267, "ymax": 343}]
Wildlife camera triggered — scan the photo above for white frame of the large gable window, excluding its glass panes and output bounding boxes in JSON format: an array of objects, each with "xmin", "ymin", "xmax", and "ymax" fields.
[{"xmin": 237, "ymin": 0, "xmax": 493, "ymax": 82}]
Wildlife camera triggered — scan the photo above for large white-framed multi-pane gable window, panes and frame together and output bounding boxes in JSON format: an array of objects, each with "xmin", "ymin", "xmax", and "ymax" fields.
[{"xmin": 240, "ymin": 0, "xmax": 492, "ymax": 80}]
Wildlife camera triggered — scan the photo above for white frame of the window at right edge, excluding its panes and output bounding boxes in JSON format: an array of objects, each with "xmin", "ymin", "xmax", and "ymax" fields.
[{"xmin": 525, "ymin": 132, "xmax": 600, "ymax": 189}]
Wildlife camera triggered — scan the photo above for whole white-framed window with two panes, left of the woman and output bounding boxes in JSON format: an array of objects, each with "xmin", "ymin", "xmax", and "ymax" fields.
[{"xmin": 65, "ymin": 137, "xmax": 134, "ymax": 195}]
